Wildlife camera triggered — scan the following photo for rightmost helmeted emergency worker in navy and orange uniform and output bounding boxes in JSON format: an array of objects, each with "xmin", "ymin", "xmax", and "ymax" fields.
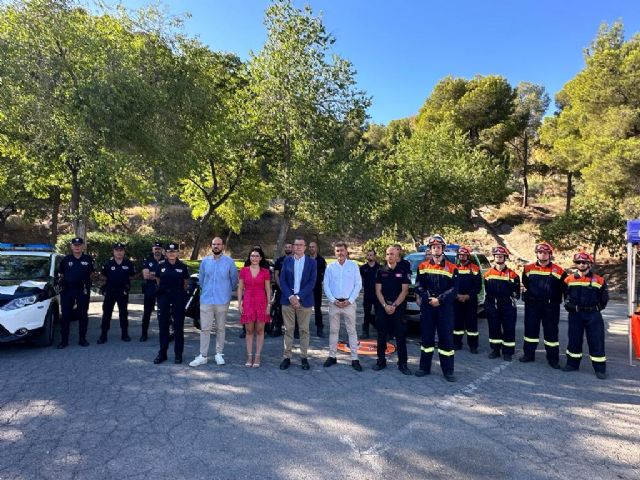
[{"xmin": 562, "ymin": 252, "xmax": 609, "ymax": 380}]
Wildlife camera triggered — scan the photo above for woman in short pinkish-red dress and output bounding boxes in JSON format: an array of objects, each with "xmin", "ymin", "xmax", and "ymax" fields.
[{"xmin": 238, "ymin": 247, "xmax": 271, "ymax": 368}]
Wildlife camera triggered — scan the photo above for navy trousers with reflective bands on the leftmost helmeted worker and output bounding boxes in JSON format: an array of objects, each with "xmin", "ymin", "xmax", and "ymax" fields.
[{"xmin": 420, "ymin": 300, "xmax": 454, "ymax": 375}]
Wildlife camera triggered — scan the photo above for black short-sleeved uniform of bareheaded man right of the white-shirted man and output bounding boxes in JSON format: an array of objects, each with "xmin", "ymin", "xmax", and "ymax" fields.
[{"xmin": 376, "ymin": 264, "xmax": 410, "ymax": 369}]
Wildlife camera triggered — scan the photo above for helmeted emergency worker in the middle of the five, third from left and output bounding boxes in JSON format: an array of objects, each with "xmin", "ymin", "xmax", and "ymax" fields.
[{"xmin": 484, "ymin": 246, "xmax": 520, "ymax": 362}]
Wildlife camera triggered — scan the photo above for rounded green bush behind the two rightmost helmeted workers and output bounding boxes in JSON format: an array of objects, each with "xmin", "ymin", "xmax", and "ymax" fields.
[{"xmin": 540, "ymin": 195, "xmax": 626, "ymax": 258}]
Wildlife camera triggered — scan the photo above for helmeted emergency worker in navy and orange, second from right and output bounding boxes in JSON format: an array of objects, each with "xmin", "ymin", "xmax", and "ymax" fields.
[{"xmin": 520, "ymin": 242, "xmax": 567, "ymax": 369}]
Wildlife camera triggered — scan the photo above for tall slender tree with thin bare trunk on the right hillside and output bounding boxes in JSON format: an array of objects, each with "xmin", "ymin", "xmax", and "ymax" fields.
[{"xmin": 507, "ymin": 82, "xmax": 549, "ymax": 207}]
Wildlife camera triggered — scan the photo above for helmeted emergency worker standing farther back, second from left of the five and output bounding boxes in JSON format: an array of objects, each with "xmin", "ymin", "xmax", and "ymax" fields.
[{"xmin": 453, "ymin": 247, "xmax": 482, "ymax": 353}]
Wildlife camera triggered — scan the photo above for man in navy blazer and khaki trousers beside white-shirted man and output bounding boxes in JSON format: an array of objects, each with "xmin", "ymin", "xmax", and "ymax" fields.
[{"xmin": 280, "ymin": 237, "xmax": 317, "ymax": 370}]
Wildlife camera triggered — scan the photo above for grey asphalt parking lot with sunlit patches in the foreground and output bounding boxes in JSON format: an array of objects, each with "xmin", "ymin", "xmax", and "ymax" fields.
[{"xmin": 0, "ymin": 303, "xmax": 640, "ymax": 480}]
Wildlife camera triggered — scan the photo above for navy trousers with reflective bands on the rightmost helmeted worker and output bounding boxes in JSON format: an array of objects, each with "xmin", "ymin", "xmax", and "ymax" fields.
[{"xmin": 567, "ymin": 312, "xmax": 607, "ymax": 372}]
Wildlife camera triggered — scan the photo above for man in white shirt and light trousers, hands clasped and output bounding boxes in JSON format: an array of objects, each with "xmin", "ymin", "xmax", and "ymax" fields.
[{"xmin": 323, "ymin": 242, "xmax": 362, "ymax": 372}]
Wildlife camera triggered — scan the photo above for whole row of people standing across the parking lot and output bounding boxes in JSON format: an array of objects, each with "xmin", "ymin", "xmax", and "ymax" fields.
[{"xmin": 58, "ymin": 235, "xmax": 608, "ymax": 381}]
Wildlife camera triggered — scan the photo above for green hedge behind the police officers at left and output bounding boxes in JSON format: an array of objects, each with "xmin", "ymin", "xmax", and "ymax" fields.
[{"xmin": 56, "ymin": 232, "xmax": 176, "ymax": 269}]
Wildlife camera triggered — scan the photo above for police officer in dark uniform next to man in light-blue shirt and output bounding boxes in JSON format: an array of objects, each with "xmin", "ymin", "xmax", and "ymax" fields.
[{"xmin": 153, "ymin": 243, "xmax": 189, "ymax": 364}]
